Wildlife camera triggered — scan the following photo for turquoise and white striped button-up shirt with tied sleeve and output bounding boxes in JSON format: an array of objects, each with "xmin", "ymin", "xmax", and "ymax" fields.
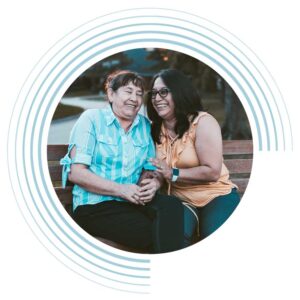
[{"xmin": 60, "ymin": 106, "xmax": 155, "ymax": 210}]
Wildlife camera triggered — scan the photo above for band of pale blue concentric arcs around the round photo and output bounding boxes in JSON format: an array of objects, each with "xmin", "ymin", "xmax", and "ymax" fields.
[{"xmin": 8, "ymin": 9, "xmax": 293, "ymax": 293}]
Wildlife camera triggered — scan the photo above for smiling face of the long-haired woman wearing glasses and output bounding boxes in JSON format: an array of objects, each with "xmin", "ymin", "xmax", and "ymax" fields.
[{"xmin": 151, "ymin": 77, "xmax": 175, "ymax": 120}]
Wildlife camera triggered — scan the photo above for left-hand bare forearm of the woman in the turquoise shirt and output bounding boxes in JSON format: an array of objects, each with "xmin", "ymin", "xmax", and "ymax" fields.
[{"xmin": 69, "ymin": 166, "xmax": 120, "ymax": 197}]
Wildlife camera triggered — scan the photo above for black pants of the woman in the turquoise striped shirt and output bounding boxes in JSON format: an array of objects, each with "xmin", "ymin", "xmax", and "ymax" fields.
[{"xmin": 73, "ymin": 194, "xmax": 184, "ymax": 253}]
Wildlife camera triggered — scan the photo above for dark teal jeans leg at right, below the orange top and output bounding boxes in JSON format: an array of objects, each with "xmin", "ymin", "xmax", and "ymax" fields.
[{"xmin": 197, "ymin": 188, "xmax": 240, "ymax": 240}]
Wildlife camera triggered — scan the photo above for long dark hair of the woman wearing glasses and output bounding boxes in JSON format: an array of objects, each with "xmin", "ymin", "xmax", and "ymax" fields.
[{"xmin": 147, "ymin": 69, "xmax": 203, "ymax": 144}]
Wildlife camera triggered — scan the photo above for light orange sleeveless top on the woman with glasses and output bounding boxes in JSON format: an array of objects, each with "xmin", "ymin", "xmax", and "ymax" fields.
[{"xmin": 156, "ymin": 112, "xmax": 237, "ymax": 207}]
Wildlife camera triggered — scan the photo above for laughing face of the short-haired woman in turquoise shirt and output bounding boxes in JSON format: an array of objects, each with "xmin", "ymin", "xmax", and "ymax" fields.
[{"xmin": 108, "ymin": 82, "xmax": 143, "ymax": 121}]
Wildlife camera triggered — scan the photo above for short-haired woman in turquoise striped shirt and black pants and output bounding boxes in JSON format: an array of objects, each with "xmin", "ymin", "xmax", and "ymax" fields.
[{"xmin": 61, "ymin": 71, "xmax": 184, "ymax": 253}]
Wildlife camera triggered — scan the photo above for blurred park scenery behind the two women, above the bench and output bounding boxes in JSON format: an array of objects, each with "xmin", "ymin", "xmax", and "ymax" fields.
[{"xmin": 48, "ymin": 48, "xmax": 252, "ymax": 144}]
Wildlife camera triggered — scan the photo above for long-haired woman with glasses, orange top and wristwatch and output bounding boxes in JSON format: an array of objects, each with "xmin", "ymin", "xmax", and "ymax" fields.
[{"xmin": 147, "ymin": 69, "xmax": 240, "ymax": 240}]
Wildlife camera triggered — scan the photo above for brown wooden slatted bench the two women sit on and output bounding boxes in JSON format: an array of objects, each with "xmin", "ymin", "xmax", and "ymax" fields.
[{"xmin": 47, "ymin": 140, "xmax": 253, "ymax": 252}]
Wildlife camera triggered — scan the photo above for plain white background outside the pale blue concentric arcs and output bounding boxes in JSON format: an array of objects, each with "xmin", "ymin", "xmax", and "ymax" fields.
[{"xmin": 0, "ymin": 0, "xmax": 300, "ymax": 300}]
